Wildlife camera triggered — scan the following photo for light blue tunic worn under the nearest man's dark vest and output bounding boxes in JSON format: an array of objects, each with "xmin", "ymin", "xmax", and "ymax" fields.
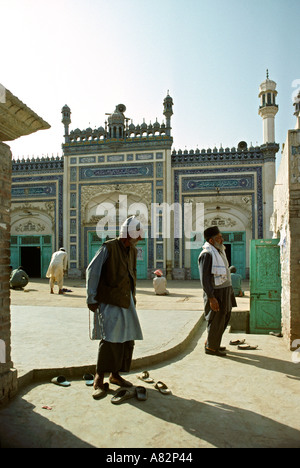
[{"xmin": 86, "ymin": 246, "xmax": 143, "ymax": 343}]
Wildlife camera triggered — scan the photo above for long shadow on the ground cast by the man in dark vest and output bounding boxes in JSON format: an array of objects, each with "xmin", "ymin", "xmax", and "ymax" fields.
[{"xmin": 123, "ymin": 387, "xmax": 300, "ymax": 448}]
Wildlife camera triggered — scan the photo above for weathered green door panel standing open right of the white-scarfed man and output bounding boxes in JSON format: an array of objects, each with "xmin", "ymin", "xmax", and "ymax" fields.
[{"xmin": 250, "ymin": 239, "xmax": 281, "ymax": 334}]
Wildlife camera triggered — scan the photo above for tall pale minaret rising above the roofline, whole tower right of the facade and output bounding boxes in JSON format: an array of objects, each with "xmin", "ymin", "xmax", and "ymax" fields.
[{"xmin": 258, "ymin": 70, "xmax": 278, "ymax": 144}]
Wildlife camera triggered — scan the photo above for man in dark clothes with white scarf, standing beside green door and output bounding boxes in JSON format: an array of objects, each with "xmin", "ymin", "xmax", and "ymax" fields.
[{"xmin": 198, "ymin": 226, "xmax": 237, "ymax": 356}]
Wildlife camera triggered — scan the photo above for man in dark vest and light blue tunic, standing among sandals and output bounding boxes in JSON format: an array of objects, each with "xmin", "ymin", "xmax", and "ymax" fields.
[{"xmin": 86, "ymin": 216, "xmax": 143, "ymax": 399}]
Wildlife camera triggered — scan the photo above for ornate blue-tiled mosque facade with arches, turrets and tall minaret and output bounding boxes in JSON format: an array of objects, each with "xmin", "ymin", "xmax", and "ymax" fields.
[{"xmin": 11, "ymin": 76, "xmax": 279, "ymax": 279}]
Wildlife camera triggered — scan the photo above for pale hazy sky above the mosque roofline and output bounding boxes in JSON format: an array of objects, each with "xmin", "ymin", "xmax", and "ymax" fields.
[{"xmin": 0, "ymin": 0, "xmax": 300, "ymax": 168}]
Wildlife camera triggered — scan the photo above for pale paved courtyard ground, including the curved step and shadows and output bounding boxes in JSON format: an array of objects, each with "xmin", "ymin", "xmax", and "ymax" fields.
[{"xmin": 0, "ymin": 280, "xmax": 300, "ymax": 453}]
